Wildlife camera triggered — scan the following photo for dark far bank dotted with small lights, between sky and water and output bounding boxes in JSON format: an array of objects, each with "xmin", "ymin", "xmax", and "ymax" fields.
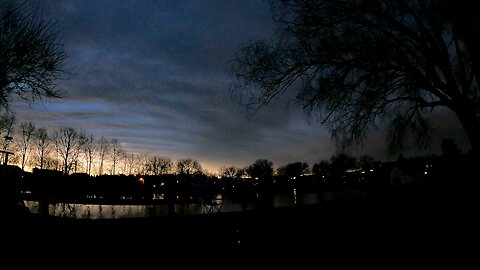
[{"xmin": 13, "ymin": 137, "xmax": 475, "ymax": 203}]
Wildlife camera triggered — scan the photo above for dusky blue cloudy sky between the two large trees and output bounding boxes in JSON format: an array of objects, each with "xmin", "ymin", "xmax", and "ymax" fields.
[{"xmin": 13, "ymin": 0, "xmax": 468, "ymax": 172}]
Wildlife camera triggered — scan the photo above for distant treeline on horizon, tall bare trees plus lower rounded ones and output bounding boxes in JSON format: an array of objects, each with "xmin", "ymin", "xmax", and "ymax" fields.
[{"xmin": 0, "ymin": 114, "xmax": 382, "ymax": 178}]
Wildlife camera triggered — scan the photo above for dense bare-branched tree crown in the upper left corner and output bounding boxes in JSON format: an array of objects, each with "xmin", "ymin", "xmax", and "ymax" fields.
[{"xmin": 0, "ymin": 0, "xmax": 66, "ymax": 109}]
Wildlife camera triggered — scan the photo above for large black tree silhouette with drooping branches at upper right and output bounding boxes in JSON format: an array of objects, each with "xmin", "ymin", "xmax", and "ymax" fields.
[{"xmin": 231, "ymin": 0, "xmax": 480, "ymax": 160}]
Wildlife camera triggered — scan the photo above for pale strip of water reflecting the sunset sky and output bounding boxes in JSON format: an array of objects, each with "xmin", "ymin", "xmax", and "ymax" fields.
[{"xmin": 24, "ymin": 190, "xmax": 363, "ymax": 219}]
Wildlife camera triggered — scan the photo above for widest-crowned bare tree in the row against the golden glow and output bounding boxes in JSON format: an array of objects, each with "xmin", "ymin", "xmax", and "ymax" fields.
[{"xmin": 52, "ymin": 127, "xmax": 82, "ymax": 175}]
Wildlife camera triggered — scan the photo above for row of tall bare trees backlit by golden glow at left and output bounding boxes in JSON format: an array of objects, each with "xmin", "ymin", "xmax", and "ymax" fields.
[{"xmin": 0, "ymin": 114, "xmax": 202, "ymax": 175}]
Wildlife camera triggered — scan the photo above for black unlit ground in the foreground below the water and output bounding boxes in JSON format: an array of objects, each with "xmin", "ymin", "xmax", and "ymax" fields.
[{"xmin": 12, "ymin": 185, "xmax": 480, "ymax": 268}]
